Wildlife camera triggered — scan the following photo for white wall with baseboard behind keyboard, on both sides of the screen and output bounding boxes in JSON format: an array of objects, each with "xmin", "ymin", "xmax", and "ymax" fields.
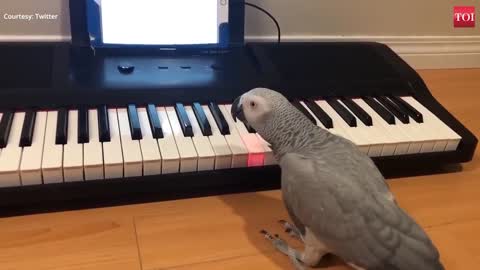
[{"xmin": 0, "ymin": 0, "xmax": 480, "ymax": 68}]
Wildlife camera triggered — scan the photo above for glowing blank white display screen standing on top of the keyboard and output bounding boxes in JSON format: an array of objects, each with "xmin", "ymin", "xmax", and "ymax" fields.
[{"xmin": 101, "ymin": 0, "xmax": 220, "ymax": 45}]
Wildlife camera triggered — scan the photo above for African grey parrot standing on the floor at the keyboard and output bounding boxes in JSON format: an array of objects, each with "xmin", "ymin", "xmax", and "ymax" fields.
[{"xmin": 231, "ymin": 88, "xmax": 444, "ymax": 270}]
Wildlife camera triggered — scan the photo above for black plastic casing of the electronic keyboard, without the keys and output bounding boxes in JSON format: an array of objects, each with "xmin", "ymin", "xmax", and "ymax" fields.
[{"xmin": 0, "ymin": 42, "xmax": 477, "ymax": 216}]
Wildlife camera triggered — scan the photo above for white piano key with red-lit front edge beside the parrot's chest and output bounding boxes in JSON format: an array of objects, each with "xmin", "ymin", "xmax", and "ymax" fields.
[{"xmin": 225, "ymin": 104, "xmax": 265, "ymax": 167}]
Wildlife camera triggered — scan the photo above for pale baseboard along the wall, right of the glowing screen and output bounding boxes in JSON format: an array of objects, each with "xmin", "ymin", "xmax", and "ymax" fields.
[{"xmin": 246, "ymin": 36, "xmax": 480, "ymax": 69}]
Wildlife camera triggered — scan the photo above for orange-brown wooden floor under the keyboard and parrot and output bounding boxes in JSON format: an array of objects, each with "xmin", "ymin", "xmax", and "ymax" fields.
[{"xmin": 0, "ymin": 70, "xmax": 480, "ymax": 270}]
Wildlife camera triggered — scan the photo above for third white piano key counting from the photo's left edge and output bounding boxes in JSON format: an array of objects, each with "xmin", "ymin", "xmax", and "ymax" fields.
[{"xmin": 42, "ymin": 111, "xmax": 63, "ymax": 184}]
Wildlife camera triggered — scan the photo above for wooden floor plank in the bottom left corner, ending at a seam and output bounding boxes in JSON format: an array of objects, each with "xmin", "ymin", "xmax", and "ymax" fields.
[{"xmin": 0, "ymin": 211, "xmax": 140, "ymax": 270}]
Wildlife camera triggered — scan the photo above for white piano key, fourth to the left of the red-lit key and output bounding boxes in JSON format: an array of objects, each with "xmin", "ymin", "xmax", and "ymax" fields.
[{"xmin": 165, "ymin": 107, "xmax": 198, "ymax": 172}]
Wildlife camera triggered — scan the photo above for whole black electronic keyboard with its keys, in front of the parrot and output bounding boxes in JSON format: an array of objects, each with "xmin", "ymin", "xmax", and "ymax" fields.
[{"xmin": 0, "ymin": 42, "xmax": 477, "ymax": 216}]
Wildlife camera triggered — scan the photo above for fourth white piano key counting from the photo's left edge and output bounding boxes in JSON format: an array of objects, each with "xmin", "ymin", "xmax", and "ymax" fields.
[{"xmin": 63, "ymin": 110, "xmax": 83, "ymax": 182}]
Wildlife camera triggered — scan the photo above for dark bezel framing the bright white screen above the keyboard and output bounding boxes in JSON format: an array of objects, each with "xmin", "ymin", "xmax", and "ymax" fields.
[{"xmin": 83, "ymin": 0, "xmax": 234, "ymax": 49}]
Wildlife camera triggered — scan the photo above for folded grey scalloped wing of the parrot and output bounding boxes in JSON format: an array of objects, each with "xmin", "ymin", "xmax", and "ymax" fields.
[{"xmin": 280, "ymin": 154, "xmax": 443, "ymax": 270}]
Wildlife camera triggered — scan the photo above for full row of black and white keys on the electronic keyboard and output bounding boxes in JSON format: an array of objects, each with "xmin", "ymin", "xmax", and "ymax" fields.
[{"xmin": 0, "ymin": 96, "xmax": 461, "ymax": 187}]
